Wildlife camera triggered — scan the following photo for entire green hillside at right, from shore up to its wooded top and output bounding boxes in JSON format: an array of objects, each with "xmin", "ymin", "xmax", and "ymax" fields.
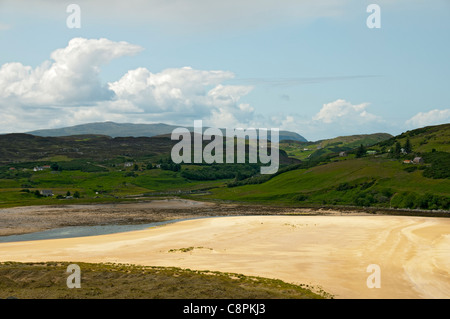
[{"xmin": 205, "ymin": 124, "xmax": 450, "ymax": 210}]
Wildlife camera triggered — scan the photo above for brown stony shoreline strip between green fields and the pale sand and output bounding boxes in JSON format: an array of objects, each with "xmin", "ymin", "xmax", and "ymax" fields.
[{"xmin": 0, "ymin": 198, "xmax": 382, "ymax": 236}]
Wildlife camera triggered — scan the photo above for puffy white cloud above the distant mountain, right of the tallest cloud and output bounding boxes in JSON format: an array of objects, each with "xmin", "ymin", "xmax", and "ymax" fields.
[{"xmin": 109, "ymin": 67, "xmax": 254, "ymax": 125}]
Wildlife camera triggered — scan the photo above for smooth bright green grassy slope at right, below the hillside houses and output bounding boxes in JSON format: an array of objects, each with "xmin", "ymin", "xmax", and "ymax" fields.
[{"xmin": 205, "ymin": 157, "xmax": 450, "ymax": 204}]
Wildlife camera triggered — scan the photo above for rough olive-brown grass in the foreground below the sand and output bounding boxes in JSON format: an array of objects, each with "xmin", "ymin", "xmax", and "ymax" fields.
[{"xmin": 0, "ymin": 262, "xmax": 332, "ymax": 299}]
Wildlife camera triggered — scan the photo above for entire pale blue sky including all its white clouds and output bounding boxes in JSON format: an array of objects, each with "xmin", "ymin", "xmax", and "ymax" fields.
[{"xmin": 0, "ymin": 0, "xmax": 450, "ymax": 140}]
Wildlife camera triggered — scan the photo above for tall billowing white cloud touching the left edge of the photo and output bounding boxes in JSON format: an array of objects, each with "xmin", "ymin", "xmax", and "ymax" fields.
[{"xmin": 0, "ymin": 38, "xmax": 142, "ymax": 105}]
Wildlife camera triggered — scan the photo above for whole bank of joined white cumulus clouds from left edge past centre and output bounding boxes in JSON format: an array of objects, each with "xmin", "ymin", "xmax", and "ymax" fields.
[{"xmin": 0, "ymin": 38, "xmax": 254, "ymax": 131}]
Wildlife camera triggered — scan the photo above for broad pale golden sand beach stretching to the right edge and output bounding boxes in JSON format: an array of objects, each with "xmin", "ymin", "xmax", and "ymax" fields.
[{"xmin": 0, "ymin": 215, "xmax": 450, "ymax": 298}]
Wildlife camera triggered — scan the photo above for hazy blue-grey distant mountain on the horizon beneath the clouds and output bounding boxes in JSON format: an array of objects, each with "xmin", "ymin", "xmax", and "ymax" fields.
[{"xmin": 26, "ymin": 122, "xmax": 307, "ymax": 142}]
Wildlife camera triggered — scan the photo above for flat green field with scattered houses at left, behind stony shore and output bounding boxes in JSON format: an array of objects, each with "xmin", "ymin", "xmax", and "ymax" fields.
[{"xmin": 0, "ymin": 168, "xmax": 224, "ymax": 207}]
